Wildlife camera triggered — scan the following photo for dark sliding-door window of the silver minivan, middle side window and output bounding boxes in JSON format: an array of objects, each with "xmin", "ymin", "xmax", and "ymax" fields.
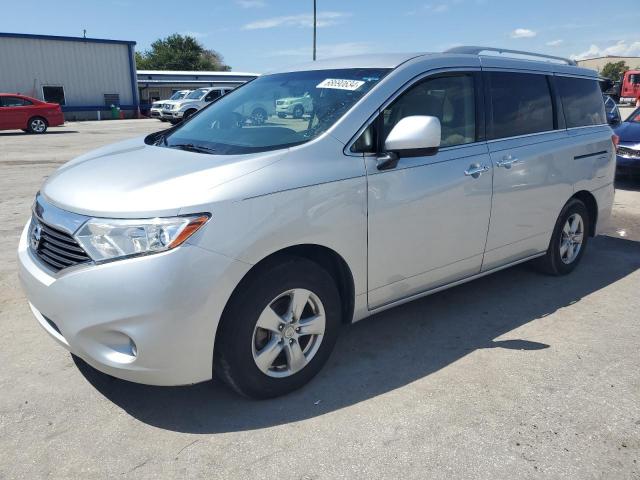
[{"xmin": 487, "ymin": 72, "xmax": 554, "ymax": 139}]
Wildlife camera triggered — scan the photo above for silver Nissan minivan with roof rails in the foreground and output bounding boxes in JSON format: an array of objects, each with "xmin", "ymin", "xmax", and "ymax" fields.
[{"xmin": 18, "ymin": 47, "xmax": 616, "ymax": 398}]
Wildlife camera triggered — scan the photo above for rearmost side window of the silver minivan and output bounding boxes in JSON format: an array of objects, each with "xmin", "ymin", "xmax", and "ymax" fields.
[{"xmin": 556, "ymin": 77, "xmax": 607, "ymax": 128}]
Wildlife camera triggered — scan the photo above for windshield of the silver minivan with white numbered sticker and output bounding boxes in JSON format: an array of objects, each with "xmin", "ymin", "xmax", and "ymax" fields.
[{"xmin": 164, "ymin": 69, "xmax": 388, "ymax": 155}]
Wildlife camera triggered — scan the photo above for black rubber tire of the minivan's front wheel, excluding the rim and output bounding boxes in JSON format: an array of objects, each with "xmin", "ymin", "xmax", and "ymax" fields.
[{"xmin": 214, "ymin": 257, "xmax": 341, "ymax": 398}]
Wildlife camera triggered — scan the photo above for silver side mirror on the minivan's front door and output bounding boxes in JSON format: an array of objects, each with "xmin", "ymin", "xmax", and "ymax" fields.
[{"xmin": 378, "ymin": 115, "xmax": 442, "ymax": 170}]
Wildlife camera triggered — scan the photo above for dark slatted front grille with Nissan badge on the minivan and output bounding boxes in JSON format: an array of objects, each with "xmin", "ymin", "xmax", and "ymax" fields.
[{"xmin": 29, "ymin": 218, "xmax": 91, "ymax": 272}]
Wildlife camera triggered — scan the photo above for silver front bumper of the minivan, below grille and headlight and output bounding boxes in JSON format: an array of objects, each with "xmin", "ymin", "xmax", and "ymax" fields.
[{"xmin": 18, "ymin": 219, "xmax": 250, "ymax": 385}]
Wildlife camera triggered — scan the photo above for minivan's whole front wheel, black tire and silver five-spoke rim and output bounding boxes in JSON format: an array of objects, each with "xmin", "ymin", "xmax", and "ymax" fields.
[{"xmin": 214, "ymin": 257, "xmax": 341, "ymax": 398}]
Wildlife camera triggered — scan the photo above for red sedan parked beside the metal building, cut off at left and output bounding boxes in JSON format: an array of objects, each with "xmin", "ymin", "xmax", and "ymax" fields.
[{"xmin": 0, "ymin": 93, "xmax": 64, "ymax": 133}]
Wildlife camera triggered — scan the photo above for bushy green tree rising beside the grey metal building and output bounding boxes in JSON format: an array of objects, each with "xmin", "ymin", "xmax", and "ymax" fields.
[{"xmin": 136, "ymin": 33, "xmax": 231, "ymax": 71}]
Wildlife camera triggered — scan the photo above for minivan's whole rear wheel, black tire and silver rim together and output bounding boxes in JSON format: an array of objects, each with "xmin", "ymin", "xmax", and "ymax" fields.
[{"xmin": 536, "ymin": 199, "xmax": 591, "ymax": 275}]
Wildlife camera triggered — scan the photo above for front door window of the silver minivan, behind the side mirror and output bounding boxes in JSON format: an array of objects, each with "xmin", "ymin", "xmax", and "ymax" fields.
[{"xmin": 380, "ymin": 75, "xmax": 476, "ymax": 147}]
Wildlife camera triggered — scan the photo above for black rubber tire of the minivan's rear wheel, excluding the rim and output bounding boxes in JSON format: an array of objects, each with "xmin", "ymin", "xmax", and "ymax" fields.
[{"xmin": 534, "ymin": 198, "xmax": 591, "ymax": 275}]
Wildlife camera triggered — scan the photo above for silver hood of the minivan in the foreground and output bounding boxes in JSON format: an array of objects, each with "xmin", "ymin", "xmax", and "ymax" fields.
[{"xmin": 41, "ymin": 137, "xmax": 286, "ymax": 218}]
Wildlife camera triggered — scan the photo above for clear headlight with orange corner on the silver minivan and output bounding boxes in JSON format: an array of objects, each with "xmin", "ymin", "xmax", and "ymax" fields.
[{"xmin": 74, "ymin": 214, "xmax": 209, "ymax": 262}]
